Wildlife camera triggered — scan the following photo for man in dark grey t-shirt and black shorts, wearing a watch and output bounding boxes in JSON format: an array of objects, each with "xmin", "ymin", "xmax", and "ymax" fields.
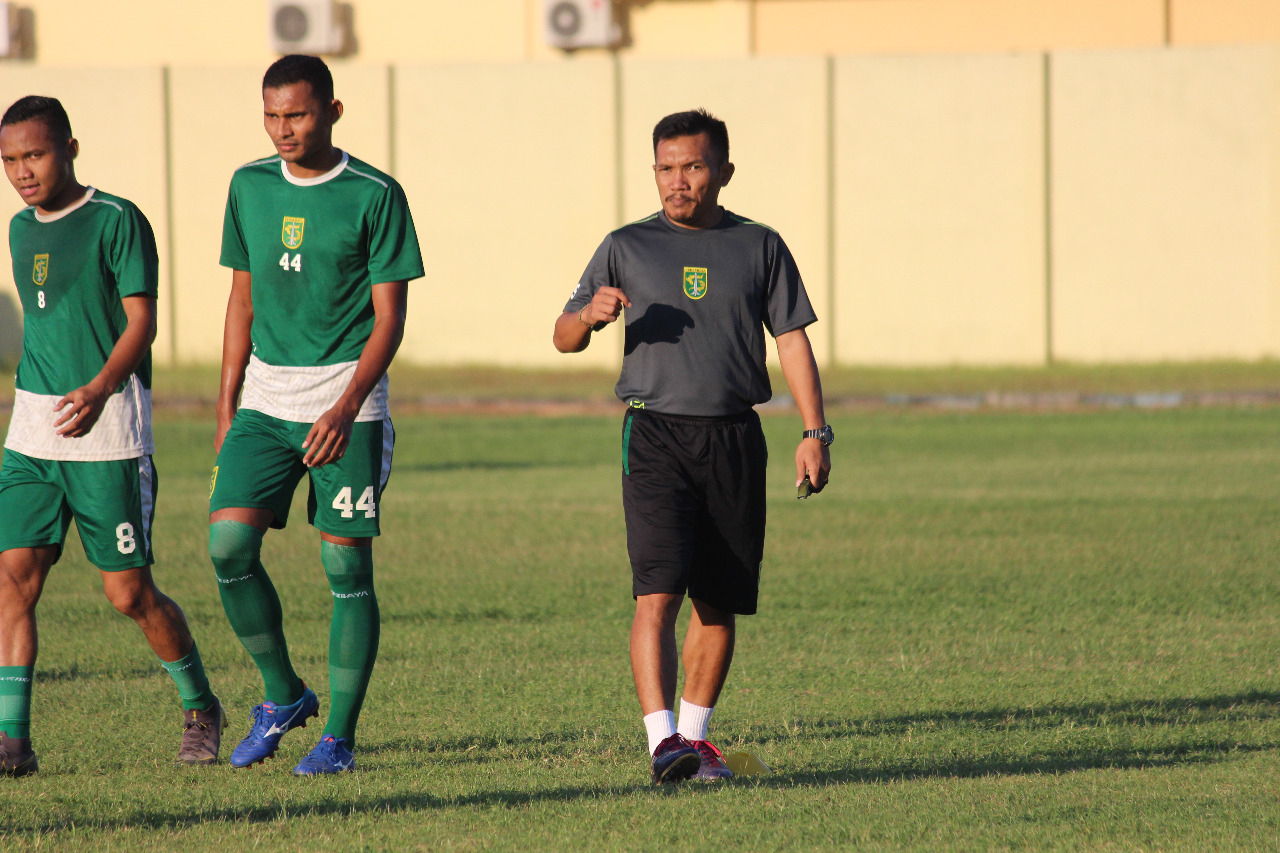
[{"xmin": 553, "ymin": 110, "xmax": 833, "ymax": 783}]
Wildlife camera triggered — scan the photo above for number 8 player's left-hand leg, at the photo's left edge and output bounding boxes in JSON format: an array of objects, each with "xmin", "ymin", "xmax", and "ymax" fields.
[{"xmin": 0, "ymin": 451, "xmax": 70, "ymax": 776}]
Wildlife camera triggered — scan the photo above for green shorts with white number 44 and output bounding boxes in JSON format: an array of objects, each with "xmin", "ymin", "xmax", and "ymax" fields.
[{"xmin": 209, "ymin": 409, "xmax": 396, "ymax": 539}]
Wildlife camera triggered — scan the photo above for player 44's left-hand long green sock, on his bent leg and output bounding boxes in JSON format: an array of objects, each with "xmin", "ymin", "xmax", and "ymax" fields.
[{"xmin": 209, "ymin": 521, "xmax": 303, "ymax": 704}]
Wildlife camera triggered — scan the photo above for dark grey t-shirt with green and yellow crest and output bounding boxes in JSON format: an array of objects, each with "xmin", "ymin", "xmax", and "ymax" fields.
[{"xmin": 564, "ymin": 210, "xmax": 818, "ymax": 418}]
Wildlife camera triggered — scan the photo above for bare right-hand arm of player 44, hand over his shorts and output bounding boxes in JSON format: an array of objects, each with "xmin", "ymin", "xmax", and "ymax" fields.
[{"xmin": 302, "ymin": 282, "xmax": 408, "ymax": 467}]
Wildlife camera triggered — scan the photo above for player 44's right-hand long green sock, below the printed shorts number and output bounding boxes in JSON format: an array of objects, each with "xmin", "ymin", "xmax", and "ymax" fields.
[{"xmin": 320, "ymin": 542, "xmax": 379, "ymax": 747}]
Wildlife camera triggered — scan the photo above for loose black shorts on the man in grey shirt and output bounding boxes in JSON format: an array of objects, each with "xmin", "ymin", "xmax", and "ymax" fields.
[{"xmin": 622, "ymin": 409, "xmax": 768, "ymax": 615}]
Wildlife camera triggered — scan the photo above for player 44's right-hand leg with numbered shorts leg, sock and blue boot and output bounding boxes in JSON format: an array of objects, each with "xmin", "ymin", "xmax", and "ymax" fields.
[{"xmin": 294, "ymin": 419, "xmax": 396, "ymax": 775}]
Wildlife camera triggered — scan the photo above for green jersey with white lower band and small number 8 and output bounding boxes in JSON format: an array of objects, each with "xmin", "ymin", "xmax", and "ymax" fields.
[{"xmin": 5, "ymin": 188, "xmax": 159, "ymax": 461}]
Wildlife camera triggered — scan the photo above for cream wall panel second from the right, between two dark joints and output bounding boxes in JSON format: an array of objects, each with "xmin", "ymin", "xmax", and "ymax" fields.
[{"xmin": 835, "ymin": 56, "xmax": 1046, "ymax": 365}]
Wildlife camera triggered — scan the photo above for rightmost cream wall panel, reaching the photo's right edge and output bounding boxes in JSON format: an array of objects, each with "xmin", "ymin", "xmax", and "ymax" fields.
[{"xmin": 1051, "ymin": 47, "xmax": 1280, "ymax": 361}]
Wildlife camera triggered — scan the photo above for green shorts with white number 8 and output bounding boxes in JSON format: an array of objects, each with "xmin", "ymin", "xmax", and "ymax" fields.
[{"xmin": 0, "ymin": 450, "xmax": 156, "ymax": 571}]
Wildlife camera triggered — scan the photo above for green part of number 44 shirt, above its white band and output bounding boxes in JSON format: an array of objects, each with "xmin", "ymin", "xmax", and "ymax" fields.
[{"xmin": 221, "ymin": 154, "xmax": 422, "ymax": 366}]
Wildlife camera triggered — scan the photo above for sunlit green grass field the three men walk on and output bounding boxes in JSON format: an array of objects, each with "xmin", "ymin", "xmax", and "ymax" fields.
[{"xmin": 0, "ymin": 409, "xmax": 1280, "ymax": 850}]
